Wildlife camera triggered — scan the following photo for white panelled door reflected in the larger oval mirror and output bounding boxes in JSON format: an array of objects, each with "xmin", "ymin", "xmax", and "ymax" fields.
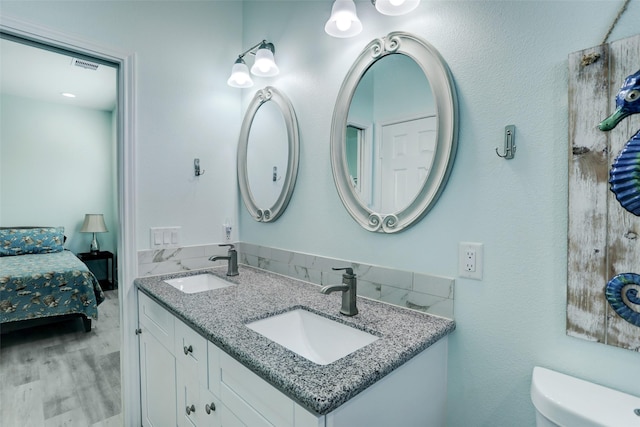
[{"xmin": 378, "ymin": 116, "xmax": 437, "ymax": 213}]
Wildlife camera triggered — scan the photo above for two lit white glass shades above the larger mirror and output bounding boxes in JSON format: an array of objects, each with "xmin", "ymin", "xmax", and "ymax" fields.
[{"xmin": 324, "ymin": 0, "xmax": 420, "ymax": 38}]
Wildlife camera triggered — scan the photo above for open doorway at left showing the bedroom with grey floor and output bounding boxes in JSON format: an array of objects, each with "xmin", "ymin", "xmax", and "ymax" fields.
[{"xmin": 0, "ymin": 34, "xmax": 121, "ymax": 425}]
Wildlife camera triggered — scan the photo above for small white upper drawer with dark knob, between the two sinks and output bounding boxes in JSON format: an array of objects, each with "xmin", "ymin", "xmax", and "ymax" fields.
[{"xmin": 175, "ymin": 319, "xmax": 208, "ymax": 384}]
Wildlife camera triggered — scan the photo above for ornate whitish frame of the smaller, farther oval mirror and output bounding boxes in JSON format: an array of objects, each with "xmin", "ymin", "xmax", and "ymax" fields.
[{"xmin": 238, "ymin": 86, "xmax": 300, "ymax": 222}]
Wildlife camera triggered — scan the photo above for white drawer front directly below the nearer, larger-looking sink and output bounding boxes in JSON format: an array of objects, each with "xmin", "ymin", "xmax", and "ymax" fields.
[{"xmin": 220, "ymin": 352, "xmax": 294, "ymax": 427}]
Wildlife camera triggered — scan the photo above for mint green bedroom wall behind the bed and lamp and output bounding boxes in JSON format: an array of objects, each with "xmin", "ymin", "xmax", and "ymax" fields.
[{"xmin": 0, "ymin": 95, "xmax": 118, "ymax": 253}]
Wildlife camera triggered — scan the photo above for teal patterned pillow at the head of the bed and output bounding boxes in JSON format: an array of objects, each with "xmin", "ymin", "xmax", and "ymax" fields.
[{"xmin": 0, "ymin": 227, "xmax": 64, "ymax": 256}]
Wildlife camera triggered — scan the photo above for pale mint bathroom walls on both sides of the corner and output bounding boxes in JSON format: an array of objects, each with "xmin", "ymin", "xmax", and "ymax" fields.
[{"xmin": 0, "ymin": 0, "xmax": 640, "ymax": 427}]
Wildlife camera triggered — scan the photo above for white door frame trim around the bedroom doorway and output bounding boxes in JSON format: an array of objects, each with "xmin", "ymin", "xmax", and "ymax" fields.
[{"xmin": 0, "ymin": 16, "xmax": 141, "ymax": 426}]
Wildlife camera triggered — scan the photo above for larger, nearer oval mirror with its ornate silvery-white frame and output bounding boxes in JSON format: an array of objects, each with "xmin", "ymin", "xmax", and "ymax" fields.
[{"xmin": 331, "ymin": 32, "xmax": 457, "ymax": 233}]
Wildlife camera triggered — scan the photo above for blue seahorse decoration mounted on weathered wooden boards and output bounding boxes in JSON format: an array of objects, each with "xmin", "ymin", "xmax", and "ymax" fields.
[{"xmin": 599, "ymin": 70, "xmax": 640, "ymax": 327}]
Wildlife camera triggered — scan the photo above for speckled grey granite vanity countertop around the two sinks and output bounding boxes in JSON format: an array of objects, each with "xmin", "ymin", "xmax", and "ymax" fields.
[{"xmin": 134, "ymin": 265, "xmax": 455, "ymax": 415}]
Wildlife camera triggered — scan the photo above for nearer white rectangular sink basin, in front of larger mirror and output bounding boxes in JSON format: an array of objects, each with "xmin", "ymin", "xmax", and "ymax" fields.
[{"xmin": 246, "ymin": 309, "xmax": 378, "ymax": 365}]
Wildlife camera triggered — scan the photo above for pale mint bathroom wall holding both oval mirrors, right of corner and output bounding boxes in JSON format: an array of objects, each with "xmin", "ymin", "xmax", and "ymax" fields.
[{"xmin": 240, "ymin": 0, "xmax": 640, "ymax": 427}]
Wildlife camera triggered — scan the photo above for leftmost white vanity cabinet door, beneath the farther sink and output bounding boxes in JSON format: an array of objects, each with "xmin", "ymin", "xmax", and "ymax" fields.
[{"xmin": 140, "ymin": 327, "xmax": 176, "ymax": 427}]
